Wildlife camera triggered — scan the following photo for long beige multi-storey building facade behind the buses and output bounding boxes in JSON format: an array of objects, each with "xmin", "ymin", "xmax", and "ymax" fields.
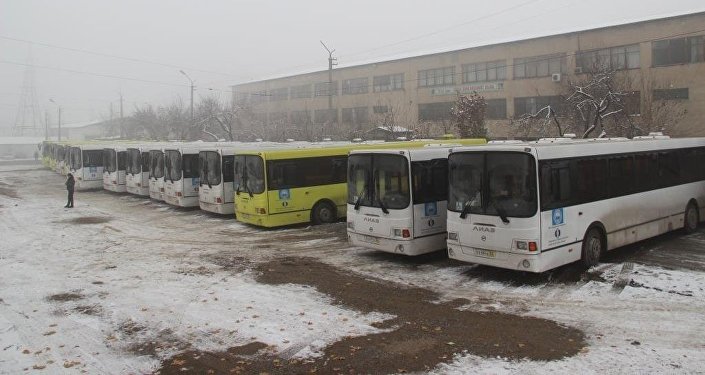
[{"xmin": 232, "ymin": 13, "xmax": 705, "ymax": 139}]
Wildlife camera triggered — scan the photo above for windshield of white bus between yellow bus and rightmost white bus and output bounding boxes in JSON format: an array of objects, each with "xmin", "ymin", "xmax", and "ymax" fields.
[{"xmin": 348, "ymin": 154, "xmax": 411, "ymax": 210}]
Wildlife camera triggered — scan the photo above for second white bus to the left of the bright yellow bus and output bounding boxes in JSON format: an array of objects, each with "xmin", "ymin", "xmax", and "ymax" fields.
[{"xmin": 164, "ymin": 143, "xmax": 213, "ymax": 207}]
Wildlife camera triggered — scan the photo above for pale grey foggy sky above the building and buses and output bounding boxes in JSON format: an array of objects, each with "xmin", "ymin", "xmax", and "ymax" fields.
[{"xmin": 0, "ymin": 0, "xmax": 705, "ymax": 134}]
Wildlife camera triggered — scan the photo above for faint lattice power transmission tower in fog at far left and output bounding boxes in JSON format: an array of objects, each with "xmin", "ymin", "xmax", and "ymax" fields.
[{"xmin": 12, "ymin": 49, "xmax": 42, "ymax": 137}]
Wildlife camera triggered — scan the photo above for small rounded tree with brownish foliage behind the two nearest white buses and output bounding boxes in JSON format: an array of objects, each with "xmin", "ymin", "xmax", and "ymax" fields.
[{"xmin": 451, "ymin": 92, "xmax": 487, "ymax": 138}]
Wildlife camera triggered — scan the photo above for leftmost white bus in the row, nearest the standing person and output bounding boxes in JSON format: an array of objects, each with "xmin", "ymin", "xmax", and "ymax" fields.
[{"xmin": 68, "ymin": 145, "xmax": 103, "ymax": 190}]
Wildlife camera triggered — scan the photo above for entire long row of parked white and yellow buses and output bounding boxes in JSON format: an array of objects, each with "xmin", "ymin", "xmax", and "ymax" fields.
[{"xmin": 43, "ymin": 133, "xmax": 705, "ymax": 272}]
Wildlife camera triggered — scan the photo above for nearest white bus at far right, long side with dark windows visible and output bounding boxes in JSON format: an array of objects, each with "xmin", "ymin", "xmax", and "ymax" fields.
[{"xmin": 448, "ymin": 136, "xmax": 705, "ymax": 272}]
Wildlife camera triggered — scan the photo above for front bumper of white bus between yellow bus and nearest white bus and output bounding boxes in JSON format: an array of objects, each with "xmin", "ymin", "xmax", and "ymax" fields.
[{"xmin": 348, "ymin": 230, "xmax": 446, "ymax": 256}]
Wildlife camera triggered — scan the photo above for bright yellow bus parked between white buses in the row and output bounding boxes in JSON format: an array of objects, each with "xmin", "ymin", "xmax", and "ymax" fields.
[{"xmin": 233, "ymin": 139, "xmax": 486, "ymax": 228}]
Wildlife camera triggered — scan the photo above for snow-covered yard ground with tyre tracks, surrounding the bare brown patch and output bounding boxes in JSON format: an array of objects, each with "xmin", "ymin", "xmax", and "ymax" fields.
[{"xmin": 0, "ymin": 167, "xmax": 705, "ymax": 374}]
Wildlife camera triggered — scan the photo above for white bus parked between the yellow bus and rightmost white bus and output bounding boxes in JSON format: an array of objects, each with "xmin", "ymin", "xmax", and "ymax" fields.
[{"xmin": 347, "ymin": 146, "xmax": 449, "ymax": 256}]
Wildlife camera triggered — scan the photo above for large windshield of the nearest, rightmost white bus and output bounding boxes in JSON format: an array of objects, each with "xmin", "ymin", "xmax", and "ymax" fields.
[{"xmin": 448, "ymin": 152, "xmax": 538, "ymax": 222}]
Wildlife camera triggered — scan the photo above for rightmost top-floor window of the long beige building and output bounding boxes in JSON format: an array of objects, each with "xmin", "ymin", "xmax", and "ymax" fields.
[{"xmin": 651, "ymin": 35, "xmax": 705, "ymax": 66}]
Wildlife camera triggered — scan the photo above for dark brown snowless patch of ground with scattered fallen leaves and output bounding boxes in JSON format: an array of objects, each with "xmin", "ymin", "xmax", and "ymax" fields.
[{"xmin": 159, "ymin": 258, "xmax": 586, "ymax": 374}]
